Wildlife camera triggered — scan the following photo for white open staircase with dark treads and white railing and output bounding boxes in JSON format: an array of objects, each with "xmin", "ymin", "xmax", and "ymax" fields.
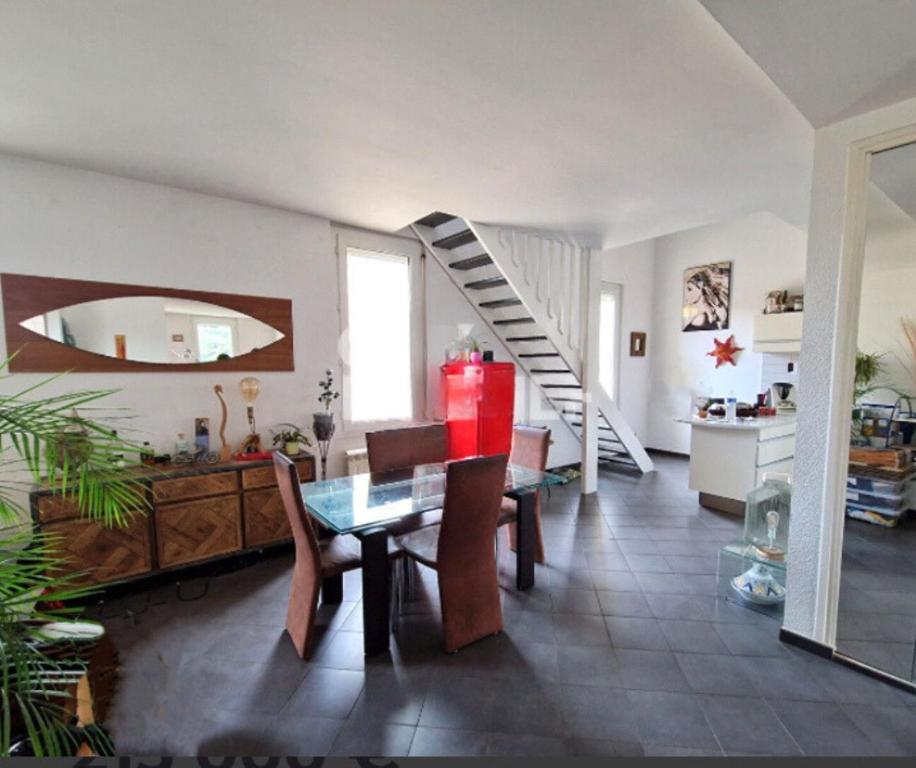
[{"xmin": 411, "ymin": 212, "xmax": 653, "ymax": 474}]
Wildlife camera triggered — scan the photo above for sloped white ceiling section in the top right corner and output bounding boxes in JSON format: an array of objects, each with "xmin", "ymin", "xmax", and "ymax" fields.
[{"xmin": 700, "ymin": 0, "xmax": 916, "ymax": 128}]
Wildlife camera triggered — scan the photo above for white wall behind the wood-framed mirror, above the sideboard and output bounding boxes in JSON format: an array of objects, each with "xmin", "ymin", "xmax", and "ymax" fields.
[{"xmin": 0, "ymin": 155, "xmax": 356, "ymax": 486}]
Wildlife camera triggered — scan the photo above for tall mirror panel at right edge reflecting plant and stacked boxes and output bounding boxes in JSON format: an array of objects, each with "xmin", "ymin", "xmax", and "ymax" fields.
[{"xmin": 836, "ymin": 144, "xmax": 916, "ymax": 680}]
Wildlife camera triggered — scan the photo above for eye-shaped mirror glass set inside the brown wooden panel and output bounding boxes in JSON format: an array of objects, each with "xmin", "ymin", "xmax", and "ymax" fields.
[{"xmin": 21, "ymin": 296, "xmax": 283, "ymax": 364}]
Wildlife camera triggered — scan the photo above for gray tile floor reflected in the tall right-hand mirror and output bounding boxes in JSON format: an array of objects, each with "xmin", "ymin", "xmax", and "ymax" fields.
[{"xmin": 837, "ymin": 514, "xmax": 916, "ymax": 680}]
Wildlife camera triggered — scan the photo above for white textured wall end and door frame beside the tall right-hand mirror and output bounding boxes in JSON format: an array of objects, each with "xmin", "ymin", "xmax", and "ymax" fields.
[{"xmin": 784, "ymin": 99, "xmax": 916, "ymax": 645}]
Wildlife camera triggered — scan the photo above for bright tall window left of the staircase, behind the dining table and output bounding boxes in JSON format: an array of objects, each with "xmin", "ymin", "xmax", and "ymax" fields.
[{"xmin": 341, "ymin": 236, "xmax": 424, "ymax": 426}]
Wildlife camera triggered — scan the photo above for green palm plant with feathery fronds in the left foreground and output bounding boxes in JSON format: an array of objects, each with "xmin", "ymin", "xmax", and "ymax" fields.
[{"xmin": 0, "ymin": 360, "xmax": 147, "ymax": 756}]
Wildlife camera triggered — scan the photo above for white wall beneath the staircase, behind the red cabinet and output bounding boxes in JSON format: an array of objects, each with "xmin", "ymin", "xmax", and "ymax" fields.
[{"xmin": 426, "ymin": 258, "xmax": 580, "ymax": 467}]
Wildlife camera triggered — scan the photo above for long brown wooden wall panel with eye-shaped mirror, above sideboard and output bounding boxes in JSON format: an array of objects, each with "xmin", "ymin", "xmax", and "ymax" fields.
[{"xmin": 0, "ymin": 274, "xmax": 293, "ymax": 372}]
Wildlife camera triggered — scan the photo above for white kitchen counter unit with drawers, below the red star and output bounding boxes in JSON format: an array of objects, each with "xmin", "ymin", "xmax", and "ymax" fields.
[{"xmin": 676, "ymin": 412, "xmax": 795, "ymax": 514}]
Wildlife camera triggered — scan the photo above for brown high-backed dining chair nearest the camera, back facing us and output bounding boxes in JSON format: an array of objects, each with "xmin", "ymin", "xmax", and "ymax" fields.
[{"xmin": 399, "ymin": 454, "xmax": 508, "ymax": 653}]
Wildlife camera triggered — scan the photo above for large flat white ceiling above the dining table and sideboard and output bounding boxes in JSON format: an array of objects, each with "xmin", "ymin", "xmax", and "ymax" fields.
[{"xmin": 0, "ymin": 0, "xmax": 816, "ymax": 246}]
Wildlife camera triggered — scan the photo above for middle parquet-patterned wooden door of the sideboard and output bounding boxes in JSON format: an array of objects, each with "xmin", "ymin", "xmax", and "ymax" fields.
[{"xmin": 155, "ymin": 494, "xmax": 242, "ymax": 568}]
